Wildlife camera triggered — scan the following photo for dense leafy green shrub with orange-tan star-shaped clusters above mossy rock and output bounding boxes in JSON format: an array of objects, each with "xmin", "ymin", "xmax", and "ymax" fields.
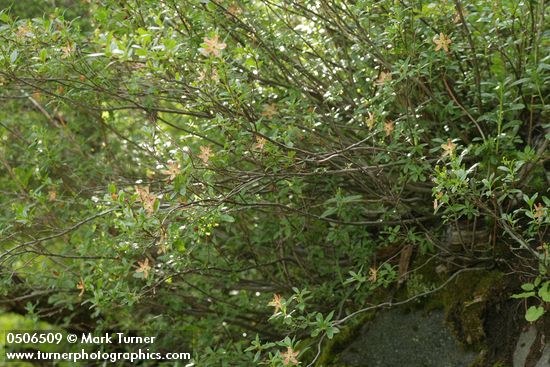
[{"xmin": 0, "ymin": 0, "xmax": 550, "ymax": 365}]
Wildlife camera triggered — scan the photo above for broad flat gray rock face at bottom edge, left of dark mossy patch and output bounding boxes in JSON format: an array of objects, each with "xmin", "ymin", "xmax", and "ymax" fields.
[{"xmin": 338, "ymin": 309, "xmax": 477, "ymax": 367}]
